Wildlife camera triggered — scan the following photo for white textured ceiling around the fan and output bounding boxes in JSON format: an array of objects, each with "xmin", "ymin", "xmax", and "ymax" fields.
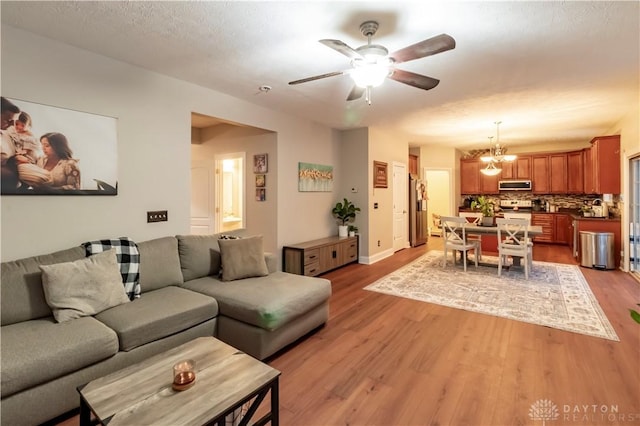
[{"xmin": 1, "ymin": 1, "xmax": 640, "ymax": 149}]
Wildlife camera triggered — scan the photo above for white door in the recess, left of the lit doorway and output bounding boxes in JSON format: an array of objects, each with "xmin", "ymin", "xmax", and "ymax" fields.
[{"xmin": 191, "ymin": 161, "xmax": 215, "ymax": 235}]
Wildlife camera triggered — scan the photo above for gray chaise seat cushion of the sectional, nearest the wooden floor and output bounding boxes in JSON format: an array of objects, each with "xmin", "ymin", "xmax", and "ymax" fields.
[{"xmin": 180, "ymin": 272, "xmax": 331, "ymax": 330}]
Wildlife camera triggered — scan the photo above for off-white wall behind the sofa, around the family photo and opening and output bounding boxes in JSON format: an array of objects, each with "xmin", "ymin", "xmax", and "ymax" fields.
[{"xmin": 0, "ymin": 25, "xmax": 339, "ymax": 261}]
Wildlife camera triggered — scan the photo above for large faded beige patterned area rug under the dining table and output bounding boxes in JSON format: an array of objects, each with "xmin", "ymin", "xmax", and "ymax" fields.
[{"xmin": 365, "ymin": 251, "xmax": 620, "ymax": 341}]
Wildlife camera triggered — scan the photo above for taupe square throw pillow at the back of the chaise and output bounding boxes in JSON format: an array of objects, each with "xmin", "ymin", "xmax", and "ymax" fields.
[{"xmin": 218, "ymin": 235, "xmax": 269, "ymax": 281}]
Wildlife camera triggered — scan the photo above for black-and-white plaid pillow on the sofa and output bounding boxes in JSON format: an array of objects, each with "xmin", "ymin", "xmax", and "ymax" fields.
[{"xmin": 82, "ymin": 237, "xmax": 140, "ymax": 300}]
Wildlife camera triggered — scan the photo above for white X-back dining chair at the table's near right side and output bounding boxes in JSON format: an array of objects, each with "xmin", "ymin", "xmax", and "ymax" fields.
[{"xmin": 496, "ymin": 218, "xmax": 533, "ymax": 280}]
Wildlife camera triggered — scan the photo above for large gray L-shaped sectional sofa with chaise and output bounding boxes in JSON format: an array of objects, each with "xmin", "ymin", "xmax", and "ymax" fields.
[{"xmin": 0, "ymin": 230, "xmax": 331, "ymax": 425}]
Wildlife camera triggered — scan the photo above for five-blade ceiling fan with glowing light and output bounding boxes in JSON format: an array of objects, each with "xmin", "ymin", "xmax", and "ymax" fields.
[{"xmin": 289, "ymin": 21, "xmax": 456, "ymax": 105}]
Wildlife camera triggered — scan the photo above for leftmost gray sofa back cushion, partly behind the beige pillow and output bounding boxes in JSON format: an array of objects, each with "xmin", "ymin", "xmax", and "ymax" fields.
[{"xmin": 0, "ymin": 247, "xmax": 85, "ymax": 325}]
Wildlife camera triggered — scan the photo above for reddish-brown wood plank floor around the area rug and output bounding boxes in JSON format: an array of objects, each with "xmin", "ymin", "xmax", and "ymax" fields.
[{"xmin": 55, "ymin": 237, "xmax": 640, "ymax": 426}]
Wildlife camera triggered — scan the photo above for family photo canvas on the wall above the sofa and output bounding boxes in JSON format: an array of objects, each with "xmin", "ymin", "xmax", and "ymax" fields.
[{"xmin": 1, "ymin": 97, "xmax": 118, "ymax": 195}]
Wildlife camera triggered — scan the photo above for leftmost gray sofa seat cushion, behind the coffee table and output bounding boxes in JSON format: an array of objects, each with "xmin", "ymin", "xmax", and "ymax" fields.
[{"xmin": 0, "ymin": 317, "xmax": 118, "ymax": 398}]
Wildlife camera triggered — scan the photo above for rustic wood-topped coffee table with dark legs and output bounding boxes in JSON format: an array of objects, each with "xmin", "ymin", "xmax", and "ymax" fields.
[{"xmin": 78, "ymin": 337, "xmax": 280, "ymax": 426}]
